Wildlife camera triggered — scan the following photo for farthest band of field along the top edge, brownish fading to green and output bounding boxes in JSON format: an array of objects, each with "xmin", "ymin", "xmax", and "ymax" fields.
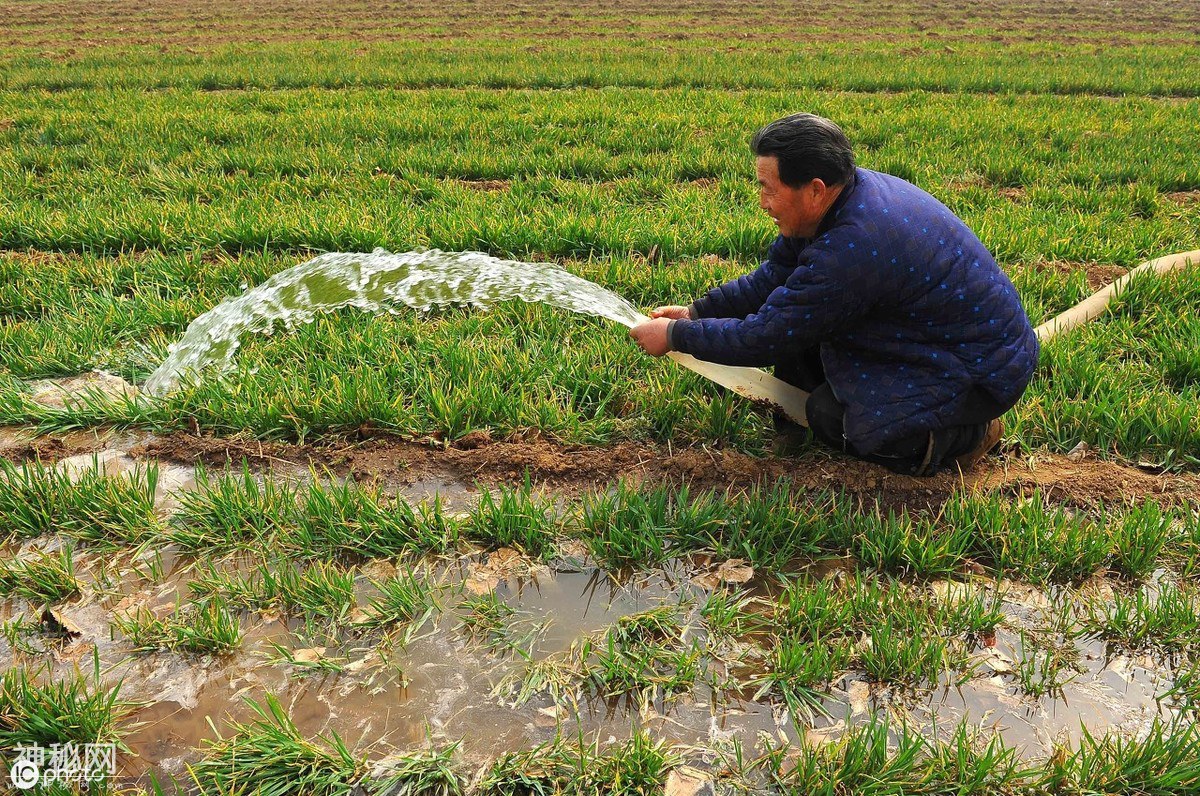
[{"xmin": 0, "ymin": 0, "xmax": 1200, "ymax": 107}]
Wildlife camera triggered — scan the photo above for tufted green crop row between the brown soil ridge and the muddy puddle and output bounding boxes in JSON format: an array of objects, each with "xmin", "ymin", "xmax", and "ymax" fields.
[{"xmin": 0, "ymin": 460, "xmax": 1200, "ymax": 583}]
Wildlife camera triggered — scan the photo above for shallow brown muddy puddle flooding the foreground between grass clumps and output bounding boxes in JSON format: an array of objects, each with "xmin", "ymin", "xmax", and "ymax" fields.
[{"xmin": 0, "ymin": 516, "xmax": 1185, "ymax": 782}]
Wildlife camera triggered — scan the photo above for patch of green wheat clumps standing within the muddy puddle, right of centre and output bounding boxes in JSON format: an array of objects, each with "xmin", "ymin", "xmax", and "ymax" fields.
[{"xmin": 496, "ymin": 577, "xmax": 1003, "ymax": 720}]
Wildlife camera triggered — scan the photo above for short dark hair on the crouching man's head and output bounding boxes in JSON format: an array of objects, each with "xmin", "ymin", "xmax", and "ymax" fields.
[{"xmin": 750, "ymin": 113, "xmax": 854, "ymax": 188}]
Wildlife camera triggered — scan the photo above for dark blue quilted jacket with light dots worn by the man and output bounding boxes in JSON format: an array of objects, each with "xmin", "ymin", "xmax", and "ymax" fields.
[{"xmin": 670, "ymin": 168, "xmax": 1038, "ymax": 454}]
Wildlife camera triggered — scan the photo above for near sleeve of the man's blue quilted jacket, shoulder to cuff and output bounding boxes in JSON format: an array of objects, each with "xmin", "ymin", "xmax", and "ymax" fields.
[{"xmin": 670, "ymin": 239, "xmax": 880, "ymax": 366}]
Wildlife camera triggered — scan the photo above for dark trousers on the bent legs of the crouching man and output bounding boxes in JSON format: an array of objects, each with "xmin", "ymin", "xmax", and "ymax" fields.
[{"xmin": 775, "ymin": 347, "xmax": 1013, "ymax": 475}]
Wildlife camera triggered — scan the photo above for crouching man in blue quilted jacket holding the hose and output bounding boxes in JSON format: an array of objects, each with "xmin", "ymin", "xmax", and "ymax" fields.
[{"xmin": 630, "ymin": 113, "xmax": 1038, "ymax": 475}]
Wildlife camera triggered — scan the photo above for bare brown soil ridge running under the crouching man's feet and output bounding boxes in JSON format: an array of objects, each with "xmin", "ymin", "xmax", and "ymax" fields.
[{"xmin": 0, "ymin": 430, "xmax": 1200, "ymax": 508}]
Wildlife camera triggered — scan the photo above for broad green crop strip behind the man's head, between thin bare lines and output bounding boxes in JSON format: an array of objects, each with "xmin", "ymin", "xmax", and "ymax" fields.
[{"xmin": 0, "ymin": 90, "xmax": 1200, "ymax": 260}]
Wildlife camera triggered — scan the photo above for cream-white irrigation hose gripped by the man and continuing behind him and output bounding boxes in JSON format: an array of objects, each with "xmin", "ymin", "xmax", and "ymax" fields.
[{"xmin": 667, "ymin": 250, "xmax": 1200, "ymax": 426}]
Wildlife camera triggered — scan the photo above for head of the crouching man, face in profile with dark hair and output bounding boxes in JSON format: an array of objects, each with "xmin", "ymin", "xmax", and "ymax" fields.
[{"xmin": 750, "ymin": 113, "xmax": 854, "ymax": 238}]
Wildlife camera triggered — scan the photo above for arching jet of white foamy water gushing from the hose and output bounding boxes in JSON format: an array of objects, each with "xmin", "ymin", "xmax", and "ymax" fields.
[{"xmin": 143, "ymin": 249, "xmax": 647, "ymax": 396}]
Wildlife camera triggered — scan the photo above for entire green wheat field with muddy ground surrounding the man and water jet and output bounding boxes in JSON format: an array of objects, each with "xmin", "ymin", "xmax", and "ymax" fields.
[{"xmin": 0, "ymin": 0, "xmax": 1200, "ymax": 796}]
